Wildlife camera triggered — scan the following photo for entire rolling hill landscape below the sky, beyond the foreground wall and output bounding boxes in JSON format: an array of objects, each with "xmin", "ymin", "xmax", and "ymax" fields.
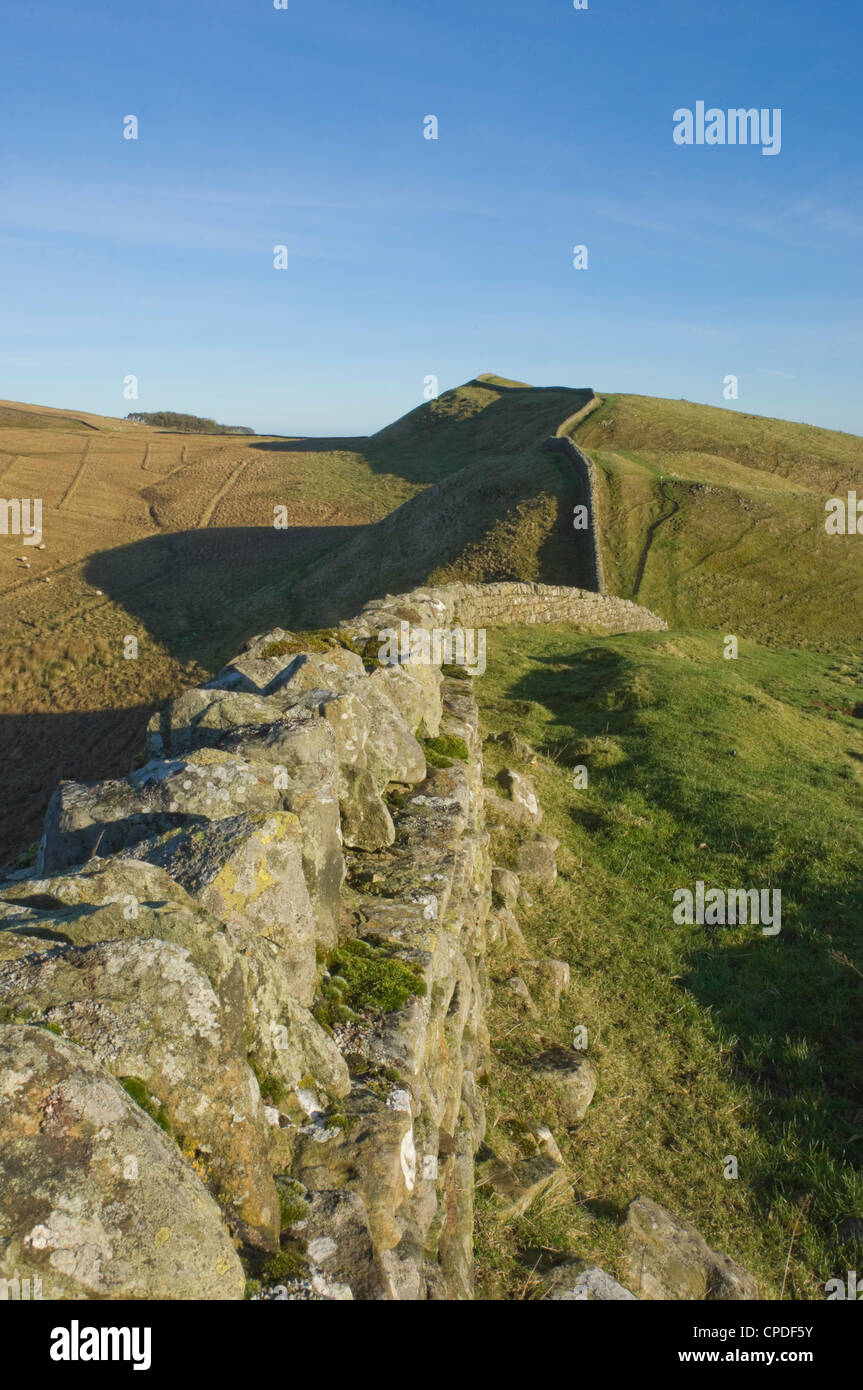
[{"xmin": 0, "ymin": 375, "xmax": 863, "ymax": 858}]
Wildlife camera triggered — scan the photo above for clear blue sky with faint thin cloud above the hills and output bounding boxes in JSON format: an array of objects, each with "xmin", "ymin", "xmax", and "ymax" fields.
[{"xmin": 0, "ymin": 0, "xmax": 863, "ymax": 434}]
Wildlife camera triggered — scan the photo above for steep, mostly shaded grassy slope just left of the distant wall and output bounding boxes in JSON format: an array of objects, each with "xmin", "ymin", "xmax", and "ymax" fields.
[{"xmin": 289, "ymin": 377, "xmax": 591, "ymax": 624}]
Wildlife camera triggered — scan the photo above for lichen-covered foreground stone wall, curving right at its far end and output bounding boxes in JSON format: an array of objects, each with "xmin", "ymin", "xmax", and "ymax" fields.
[{"xmin": 0, "ymin": 584, "xmax": 664, "ymax": 1300}]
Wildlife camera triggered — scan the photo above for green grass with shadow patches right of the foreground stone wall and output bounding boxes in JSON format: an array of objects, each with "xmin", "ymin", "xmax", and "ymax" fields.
[{"xmin": 474, "ymin": 627, "xmax": 863, "ymax": 1298}]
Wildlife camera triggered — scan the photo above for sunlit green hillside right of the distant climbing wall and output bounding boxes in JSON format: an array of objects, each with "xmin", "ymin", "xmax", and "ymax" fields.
[{"xmin": 574, "ymin": 396, "xmax": 863, "ymax": 651}]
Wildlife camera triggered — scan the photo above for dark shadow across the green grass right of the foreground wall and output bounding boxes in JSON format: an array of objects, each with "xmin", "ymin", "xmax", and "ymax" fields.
[{"xmin": 507, "ymin": 646, "xmax": 863, "ymax": 1238}]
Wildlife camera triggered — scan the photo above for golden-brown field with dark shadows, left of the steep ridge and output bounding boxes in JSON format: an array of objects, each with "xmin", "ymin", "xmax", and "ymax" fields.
[{"xmin": 0, "ymin": 403, "xmax": 416, "ymax": 862}]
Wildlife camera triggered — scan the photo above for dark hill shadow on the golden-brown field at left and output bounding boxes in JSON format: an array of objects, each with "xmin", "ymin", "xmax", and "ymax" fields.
[{"xmin": 0, "ymin": 527, "xmax": 361, "ymax": 863}]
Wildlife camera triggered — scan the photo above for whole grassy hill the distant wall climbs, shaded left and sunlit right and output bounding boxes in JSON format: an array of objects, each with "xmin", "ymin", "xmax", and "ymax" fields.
[{"xmin": 289, "ymin": 377, "xmax": 863, "ymax": 651}]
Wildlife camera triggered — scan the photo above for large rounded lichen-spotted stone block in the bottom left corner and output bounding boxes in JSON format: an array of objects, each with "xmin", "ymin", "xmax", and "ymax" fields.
[{"xmin": 0, "ymin": 1027, "xmax": 245, "ymax": 1301}]
